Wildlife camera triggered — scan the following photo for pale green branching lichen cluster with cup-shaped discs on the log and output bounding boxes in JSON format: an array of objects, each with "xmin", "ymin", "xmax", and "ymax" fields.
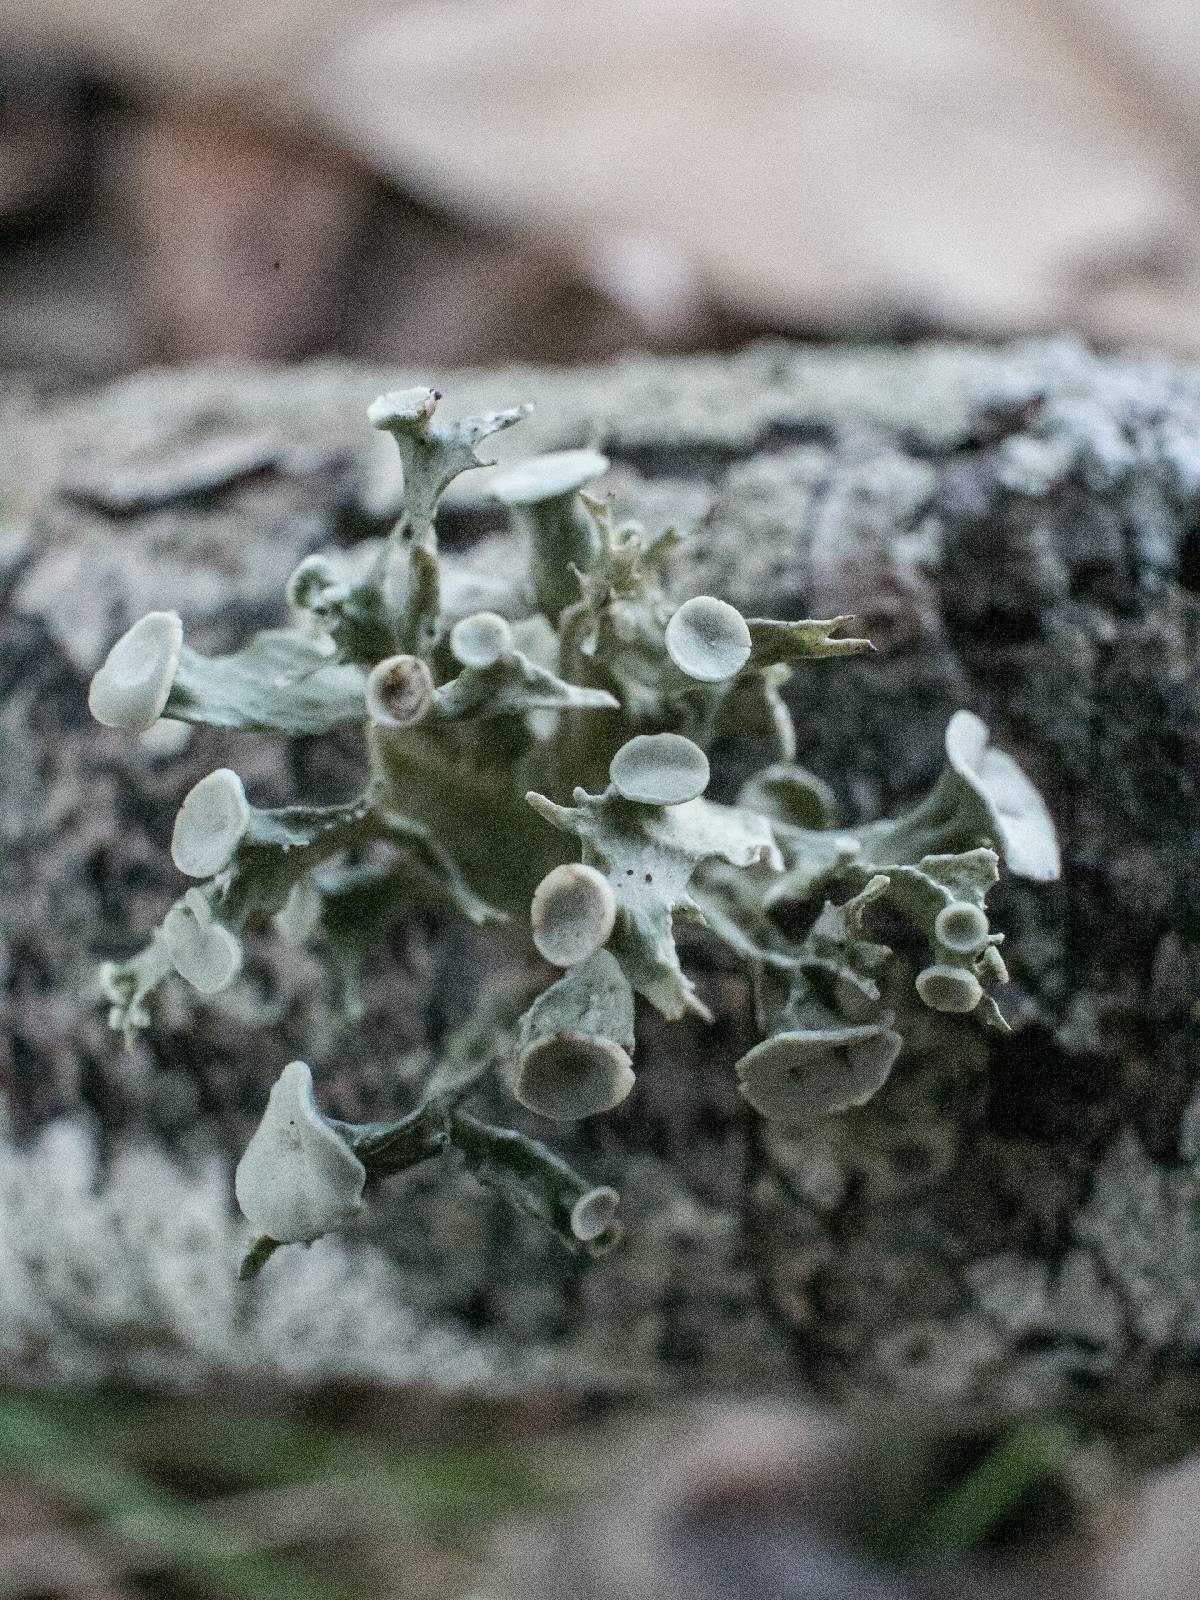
[{"xmin": 90, "ymin": 390, "xmax": 1058, "ymax": 1272}]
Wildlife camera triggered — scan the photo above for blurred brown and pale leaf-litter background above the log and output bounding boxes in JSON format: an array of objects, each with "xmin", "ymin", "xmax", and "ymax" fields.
[{"xmin": 0, "ymin": 0, "xmax": 1200, "ymax": 381}]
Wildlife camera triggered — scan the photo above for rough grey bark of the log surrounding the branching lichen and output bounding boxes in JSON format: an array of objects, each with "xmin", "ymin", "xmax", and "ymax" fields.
[{"xmin": 0, "ymin": 346, "xmax": 1200, "ymax": 1452}]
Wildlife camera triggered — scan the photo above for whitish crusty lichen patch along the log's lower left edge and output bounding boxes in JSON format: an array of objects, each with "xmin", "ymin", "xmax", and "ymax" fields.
[{"xmin": 0, "ymin": 1107, "xmax": 499, "ymax": 1392}]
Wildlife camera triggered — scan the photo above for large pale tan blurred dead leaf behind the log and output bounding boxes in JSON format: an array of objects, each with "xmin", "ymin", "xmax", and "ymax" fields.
[{"xmin": 0, "ymin": 0, "xmax": 1200, "ymax": 361}]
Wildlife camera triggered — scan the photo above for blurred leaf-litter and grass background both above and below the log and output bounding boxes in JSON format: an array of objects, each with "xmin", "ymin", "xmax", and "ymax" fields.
[{"xmin": 0, "ymin": 0, "xmax": 1200, "ymax": 1600}]
